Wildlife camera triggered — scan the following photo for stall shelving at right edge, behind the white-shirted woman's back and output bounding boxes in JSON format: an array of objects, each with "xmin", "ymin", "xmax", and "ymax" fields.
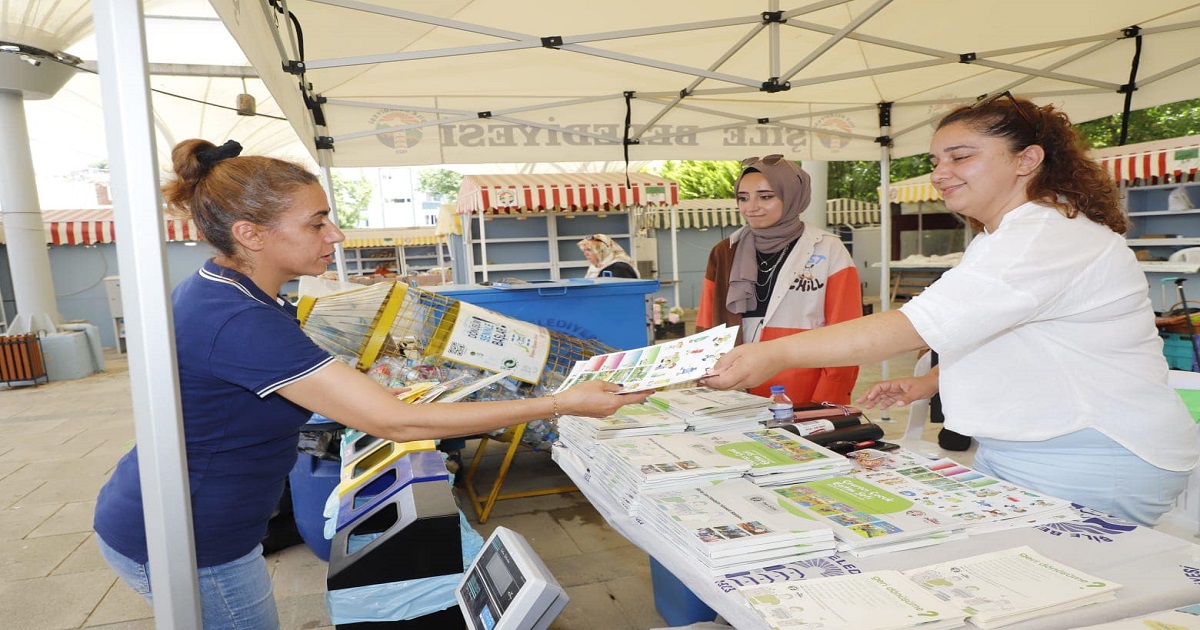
[{"xmin": 1124, "ymin": 181, "xmax": 1200, "ymax": 311}]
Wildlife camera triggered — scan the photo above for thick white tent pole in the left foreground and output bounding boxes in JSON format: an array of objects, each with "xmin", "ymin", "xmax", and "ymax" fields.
[{"xmin": 91, "ymin": 0, "xmax": 200, "ymax": 630}]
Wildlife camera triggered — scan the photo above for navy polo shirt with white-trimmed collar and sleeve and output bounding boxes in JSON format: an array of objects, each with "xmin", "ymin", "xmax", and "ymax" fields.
[{"xmin": 94, "ymin": 260, "xmax": 334, "ymax": 566}]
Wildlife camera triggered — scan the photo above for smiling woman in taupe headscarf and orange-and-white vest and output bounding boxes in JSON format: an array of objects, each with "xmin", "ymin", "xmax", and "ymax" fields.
[{"xmin": 696, "ymin": 155, "xmax": 863, "ymax": 404}]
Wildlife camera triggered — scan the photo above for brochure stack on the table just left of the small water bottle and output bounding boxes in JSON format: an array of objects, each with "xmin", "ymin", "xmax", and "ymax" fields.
[{"xmin": 649, "ymin": 386, "xmax": 772, "ymax": 433}]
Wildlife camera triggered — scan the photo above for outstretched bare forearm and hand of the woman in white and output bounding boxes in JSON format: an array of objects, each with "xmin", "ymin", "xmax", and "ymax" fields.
[{"xmin": 701, "ymin": 311, "xmax": 925, "ymax": 389}]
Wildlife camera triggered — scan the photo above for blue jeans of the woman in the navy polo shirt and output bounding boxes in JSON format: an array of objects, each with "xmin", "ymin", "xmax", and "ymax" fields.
[{"xmin": 96, "ymin": 536, "xmax": 280, "ymax": 630}]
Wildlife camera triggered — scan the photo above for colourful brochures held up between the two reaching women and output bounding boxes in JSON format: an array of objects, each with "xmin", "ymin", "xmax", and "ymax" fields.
[{"xmin": 554, "ymin": 324, "xmax": 738, "ymax": 392}]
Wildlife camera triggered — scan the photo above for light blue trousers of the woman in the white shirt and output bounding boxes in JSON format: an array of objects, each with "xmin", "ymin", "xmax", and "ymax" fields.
[{"xmin": 973, "ymin": 428, "xmax": 1190, "ymax": 527}]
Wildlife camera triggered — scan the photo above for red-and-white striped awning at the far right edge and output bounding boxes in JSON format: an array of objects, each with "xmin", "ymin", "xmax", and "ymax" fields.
[{"xmin": 1091, "ymin": 136, "xmax": 1200, "ymax": 185}]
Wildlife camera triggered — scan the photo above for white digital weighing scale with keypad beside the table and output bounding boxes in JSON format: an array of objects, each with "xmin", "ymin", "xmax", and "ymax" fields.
[{"xmin": 455, "ymin": 527, "xmax": 570, "ymax": 630}]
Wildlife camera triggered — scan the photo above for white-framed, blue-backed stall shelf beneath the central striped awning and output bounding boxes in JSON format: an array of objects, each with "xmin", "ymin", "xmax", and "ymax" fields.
[{"xmin": 463, "ymin": 211, "xmax": 637, "ymax": 282}]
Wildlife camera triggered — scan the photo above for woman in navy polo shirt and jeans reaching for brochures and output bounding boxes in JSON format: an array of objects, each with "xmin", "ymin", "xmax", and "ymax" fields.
[{"xmin": 94, "ymin": 139, "xmax": 649, "ymax": 630}]
